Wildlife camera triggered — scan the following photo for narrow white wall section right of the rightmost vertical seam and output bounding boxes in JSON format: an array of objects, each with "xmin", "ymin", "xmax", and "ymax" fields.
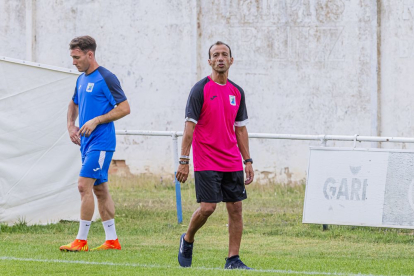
[{"xmin": 381, "ymin": 0, "xmax": 414, "ymax": 149}]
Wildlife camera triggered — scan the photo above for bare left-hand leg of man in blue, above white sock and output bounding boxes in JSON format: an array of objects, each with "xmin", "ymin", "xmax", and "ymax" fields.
[{"xmin": 78, "ymin": 176, "xmax": 96, "ymax": 220}]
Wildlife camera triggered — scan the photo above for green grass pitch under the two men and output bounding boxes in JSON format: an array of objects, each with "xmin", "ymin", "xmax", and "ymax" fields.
[{"xmin": 0, "ymin": 177, "xmax": 414, "ymax": 275}]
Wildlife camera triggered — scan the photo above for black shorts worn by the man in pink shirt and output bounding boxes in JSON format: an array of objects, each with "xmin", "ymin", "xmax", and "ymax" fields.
[{"xmin": 194, "ymin": 171, "xmax": 247, "ymax": 203}]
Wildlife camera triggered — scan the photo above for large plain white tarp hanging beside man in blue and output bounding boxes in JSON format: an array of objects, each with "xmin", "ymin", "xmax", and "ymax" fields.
[{"xmin": 0, "ymin": 57, "xmax": 96, "ymax": 224}]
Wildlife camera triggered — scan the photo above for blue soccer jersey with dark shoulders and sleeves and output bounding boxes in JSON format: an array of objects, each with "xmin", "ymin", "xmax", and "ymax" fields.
[{"xmin": 72, "ymin": 66, "xmax": 127, "ymax": 155}]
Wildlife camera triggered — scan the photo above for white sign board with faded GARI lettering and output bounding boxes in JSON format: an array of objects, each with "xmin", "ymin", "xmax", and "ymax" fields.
[{"xmin": 303, "ymin": 148, "xmax": 414, "ymax": 229}]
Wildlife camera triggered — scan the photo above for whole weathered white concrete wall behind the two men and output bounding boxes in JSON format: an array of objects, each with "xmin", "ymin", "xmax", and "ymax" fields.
[{"xmin": 0, "ymin": 0, "xmax": 408, "ymax": 182}]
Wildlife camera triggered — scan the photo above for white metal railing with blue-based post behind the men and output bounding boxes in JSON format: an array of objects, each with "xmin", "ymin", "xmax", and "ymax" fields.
[{"xmin": 116, "ymin": 130, "xmax": 414, "ymax": 223}]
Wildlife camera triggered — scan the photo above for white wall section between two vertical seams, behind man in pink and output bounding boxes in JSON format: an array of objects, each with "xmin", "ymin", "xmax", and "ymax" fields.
[{"xmin": 199, "ymin": 0, "xmax": 376, "ymax": 181}]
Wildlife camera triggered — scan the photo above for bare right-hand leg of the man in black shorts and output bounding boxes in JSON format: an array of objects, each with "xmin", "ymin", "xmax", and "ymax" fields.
[{"xmin": 226, "ymin": 201, "xmax": 243, "ymax": 257}]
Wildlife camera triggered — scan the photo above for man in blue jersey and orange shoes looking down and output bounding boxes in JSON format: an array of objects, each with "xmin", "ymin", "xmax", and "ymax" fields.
[{"xmin": 60, "ymin": 36, "xmax": 130, "ymax": 251}]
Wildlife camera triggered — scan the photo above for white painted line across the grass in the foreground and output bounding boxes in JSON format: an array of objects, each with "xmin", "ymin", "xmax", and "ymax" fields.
[{"xmin": 0, "ymin": 256, "xmax": 394, "ymax": 276}]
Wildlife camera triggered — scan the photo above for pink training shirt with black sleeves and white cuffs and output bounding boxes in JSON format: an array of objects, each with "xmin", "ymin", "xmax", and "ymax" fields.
[{"xmin": 185, "ymin": 77, "xmax": 248, "ymax": 172}]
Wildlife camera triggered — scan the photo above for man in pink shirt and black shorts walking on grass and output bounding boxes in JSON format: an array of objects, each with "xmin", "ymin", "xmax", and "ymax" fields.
[{"xmin": 177, "ymin": 41, "xmax": 254, "ymax": 269}]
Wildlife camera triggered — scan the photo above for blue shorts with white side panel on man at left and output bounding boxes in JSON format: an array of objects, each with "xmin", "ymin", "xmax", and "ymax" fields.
[{"xmin": 79, "ymin": 150, "xmax": 114, "ymax": 186}]
